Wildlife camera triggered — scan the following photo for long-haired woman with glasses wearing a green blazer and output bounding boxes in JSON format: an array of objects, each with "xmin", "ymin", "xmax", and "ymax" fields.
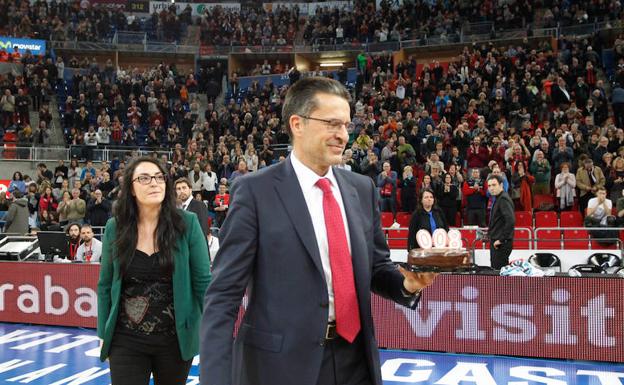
[{"xmin": 98, "ymin": 158, "xmax": 210, "ymax": 385}]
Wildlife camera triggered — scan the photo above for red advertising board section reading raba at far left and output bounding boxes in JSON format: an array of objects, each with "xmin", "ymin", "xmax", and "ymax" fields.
[{"xmin": 0, "ymin": 262, "xmax": 100, "ymax": 327}]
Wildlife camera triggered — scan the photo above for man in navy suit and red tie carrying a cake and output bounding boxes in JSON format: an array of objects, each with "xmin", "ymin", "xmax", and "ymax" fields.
[{"xmin": 200, "ymin": 77, "xmax": 435, "ymax": 385}]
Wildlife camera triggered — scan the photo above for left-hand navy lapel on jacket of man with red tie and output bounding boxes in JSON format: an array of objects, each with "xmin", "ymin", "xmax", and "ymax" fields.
[{"xmin": 275, "ymin": 157, "xmax": 325, "ymax": 276}]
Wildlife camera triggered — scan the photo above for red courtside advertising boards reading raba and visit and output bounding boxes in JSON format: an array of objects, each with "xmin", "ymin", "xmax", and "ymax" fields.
[{"xmin": 0, "ymin": 262, "xmax": 624, "ymax": 362}]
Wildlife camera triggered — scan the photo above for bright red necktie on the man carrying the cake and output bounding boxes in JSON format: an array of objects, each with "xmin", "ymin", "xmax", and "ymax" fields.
[{"xmin": 316, "ymin": 178, "xmax": 360, "ymax": 342}]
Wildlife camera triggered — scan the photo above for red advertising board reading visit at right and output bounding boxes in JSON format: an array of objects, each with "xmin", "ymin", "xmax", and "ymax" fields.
[{"xmin": 373, "ymin": 275, "xmax": 624, "ymax": 362}]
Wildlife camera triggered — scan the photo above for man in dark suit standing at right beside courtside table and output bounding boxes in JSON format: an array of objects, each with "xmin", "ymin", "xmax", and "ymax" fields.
[{"xmin": 487, "ymin": 175, "xmax": 516, "ymax": 270}]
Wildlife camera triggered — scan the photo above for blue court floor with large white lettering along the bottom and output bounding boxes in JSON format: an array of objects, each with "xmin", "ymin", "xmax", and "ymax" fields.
[{"xmin": 0, "ymin": 323, "xmax": 624, "ymax": 385}]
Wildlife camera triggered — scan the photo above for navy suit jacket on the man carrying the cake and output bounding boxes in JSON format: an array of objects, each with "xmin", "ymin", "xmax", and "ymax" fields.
[{"xmin": 200, "ymin": 158, "xmax": 417, "ymax": 385}]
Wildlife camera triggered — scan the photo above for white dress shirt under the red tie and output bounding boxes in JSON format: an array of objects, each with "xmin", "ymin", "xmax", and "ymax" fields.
[{"xmin": 290, "ymin": 151, "xmax": 351, "ymax": 322}]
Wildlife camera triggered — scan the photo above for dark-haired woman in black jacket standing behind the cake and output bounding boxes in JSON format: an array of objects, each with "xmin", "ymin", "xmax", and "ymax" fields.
[{"xmin": 407, "ymin": 188, "xmax": 448, "ymax": 251}]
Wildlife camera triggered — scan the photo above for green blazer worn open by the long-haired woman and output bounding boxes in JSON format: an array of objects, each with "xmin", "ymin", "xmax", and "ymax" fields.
[{"xmin": 97, "ymin": 210, "xmax": 210, "ymax": 361}]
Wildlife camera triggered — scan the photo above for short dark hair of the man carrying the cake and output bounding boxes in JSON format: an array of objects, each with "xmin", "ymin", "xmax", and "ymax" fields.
[{"xmin": 282, "ymin": 77, "xmax": 351, "ymax": 137}]
